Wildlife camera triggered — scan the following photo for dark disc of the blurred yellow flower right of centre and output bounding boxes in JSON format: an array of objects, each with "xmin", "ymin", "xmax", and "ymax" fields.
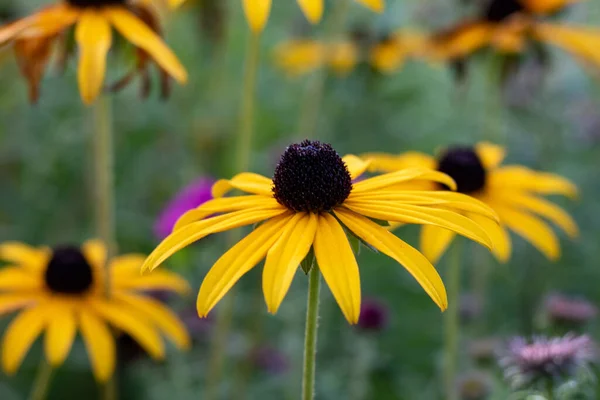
[{"xmin": 437, "ymin": 147, "xmax": 486, "ymax": 194}]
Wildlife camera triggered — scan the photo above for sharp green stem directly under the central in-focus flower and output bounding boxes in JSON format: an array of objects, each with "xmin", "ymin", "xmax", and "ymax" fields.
[{"xmin": 302, "ymin": 264, "xmax": 321, "ymax": 400}]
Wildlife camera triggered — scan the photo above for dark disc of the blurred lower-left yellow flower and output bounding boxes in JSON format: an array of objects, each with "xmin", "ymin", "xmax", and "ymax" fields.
[{"xmin": 45, "ymin": 246, "xmax": 93, "ymax": 294}]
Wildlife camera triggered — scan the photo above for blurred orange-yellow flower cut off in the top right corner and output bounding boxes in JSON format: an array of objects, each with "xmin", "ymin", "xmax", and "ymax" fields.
[{"xmin": 431, "ymin": 0, "xmax": 600, "ymax": 66}]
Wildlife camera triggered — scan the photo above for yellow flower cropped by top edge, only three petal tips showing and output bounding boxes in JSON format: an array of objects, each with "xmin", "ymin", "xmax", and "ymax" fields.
[{"xmin": 243, "ymin": 0, "xmax": 384, "ymax": 32}]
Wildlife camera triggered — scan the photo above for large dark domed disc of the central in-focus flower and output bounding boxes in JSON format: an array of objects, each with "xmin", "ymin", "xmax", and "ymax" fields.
[{"xmin": 273, "ymin": 140, "xmax": 352, "ymax": 213}]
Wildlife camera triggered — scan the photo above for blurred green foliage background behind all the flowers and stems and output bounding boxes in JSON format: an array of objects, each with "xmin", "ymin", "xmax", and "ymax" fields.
[{"xmin": 0, "ymin": 0, "xmax": 600, "ymax": 400}]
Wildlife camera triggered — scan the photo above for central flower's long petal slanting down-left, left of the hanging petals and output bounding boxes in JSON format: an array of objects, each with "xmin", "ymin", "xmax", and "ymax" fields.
[{"xmin": 196, "ymin": 213, "xmax": 291, "ymax": 317}]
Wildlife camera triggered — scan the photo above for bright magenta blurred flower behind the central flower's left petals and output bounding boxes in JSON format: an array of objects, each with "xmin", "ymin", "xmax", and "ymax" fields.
[{"xmin": 154, "ymin": 177, "xmax": 214, "ymax": 239}]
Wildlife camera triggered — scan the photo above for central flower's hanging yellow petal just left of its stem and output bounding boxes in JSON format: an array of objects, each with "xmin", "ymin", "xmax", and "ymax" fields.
[{"xmin": 262, "ymin": 213, "xmax": 318, "ymax": 314}]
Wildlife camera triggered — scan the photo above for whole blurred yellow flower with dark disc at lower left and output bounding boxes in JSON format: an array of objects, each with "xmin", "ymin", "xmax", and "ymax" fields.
[{"xmin": 0, "ymin": 241, "xmax": 190, "ymax": 381}]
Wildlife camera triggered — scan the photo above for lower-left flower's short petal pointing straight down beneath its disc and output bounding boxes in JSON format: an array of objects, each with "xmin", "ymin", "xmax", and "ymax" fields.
[{"xmin": 44, "ymin": 302, "xmax": 77, "ymax": 367}]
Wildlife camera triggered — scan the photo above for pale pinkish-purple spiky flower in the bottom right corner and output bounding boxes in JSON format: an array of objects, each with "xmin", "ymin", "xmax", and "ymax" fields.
[{"xmin": 499, "ymin": 334, "xmax": 597, "ymax": 388}]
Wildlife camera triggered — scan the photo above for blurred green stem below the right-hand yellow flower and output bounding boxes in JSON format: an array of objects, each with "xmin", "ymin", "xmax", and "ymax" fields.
[{"xmin": 444, "ymin": 240, "xmax": 462, "ymax": 400}]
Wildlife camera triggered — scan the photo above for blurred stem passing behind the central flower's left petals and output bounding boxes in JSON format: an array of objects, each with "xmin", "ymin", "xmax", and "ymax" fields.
[{"xmin": 205, "ymin": 32, "xmax": 260, "ymax": 400}]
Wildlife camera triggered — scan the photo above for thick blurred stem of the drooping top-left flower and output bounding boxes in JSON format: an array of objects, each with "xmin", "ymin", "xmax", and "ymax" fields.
[{"xmin": 92, "ymin": 96, "xmax": 117, "ymax": 400}]
